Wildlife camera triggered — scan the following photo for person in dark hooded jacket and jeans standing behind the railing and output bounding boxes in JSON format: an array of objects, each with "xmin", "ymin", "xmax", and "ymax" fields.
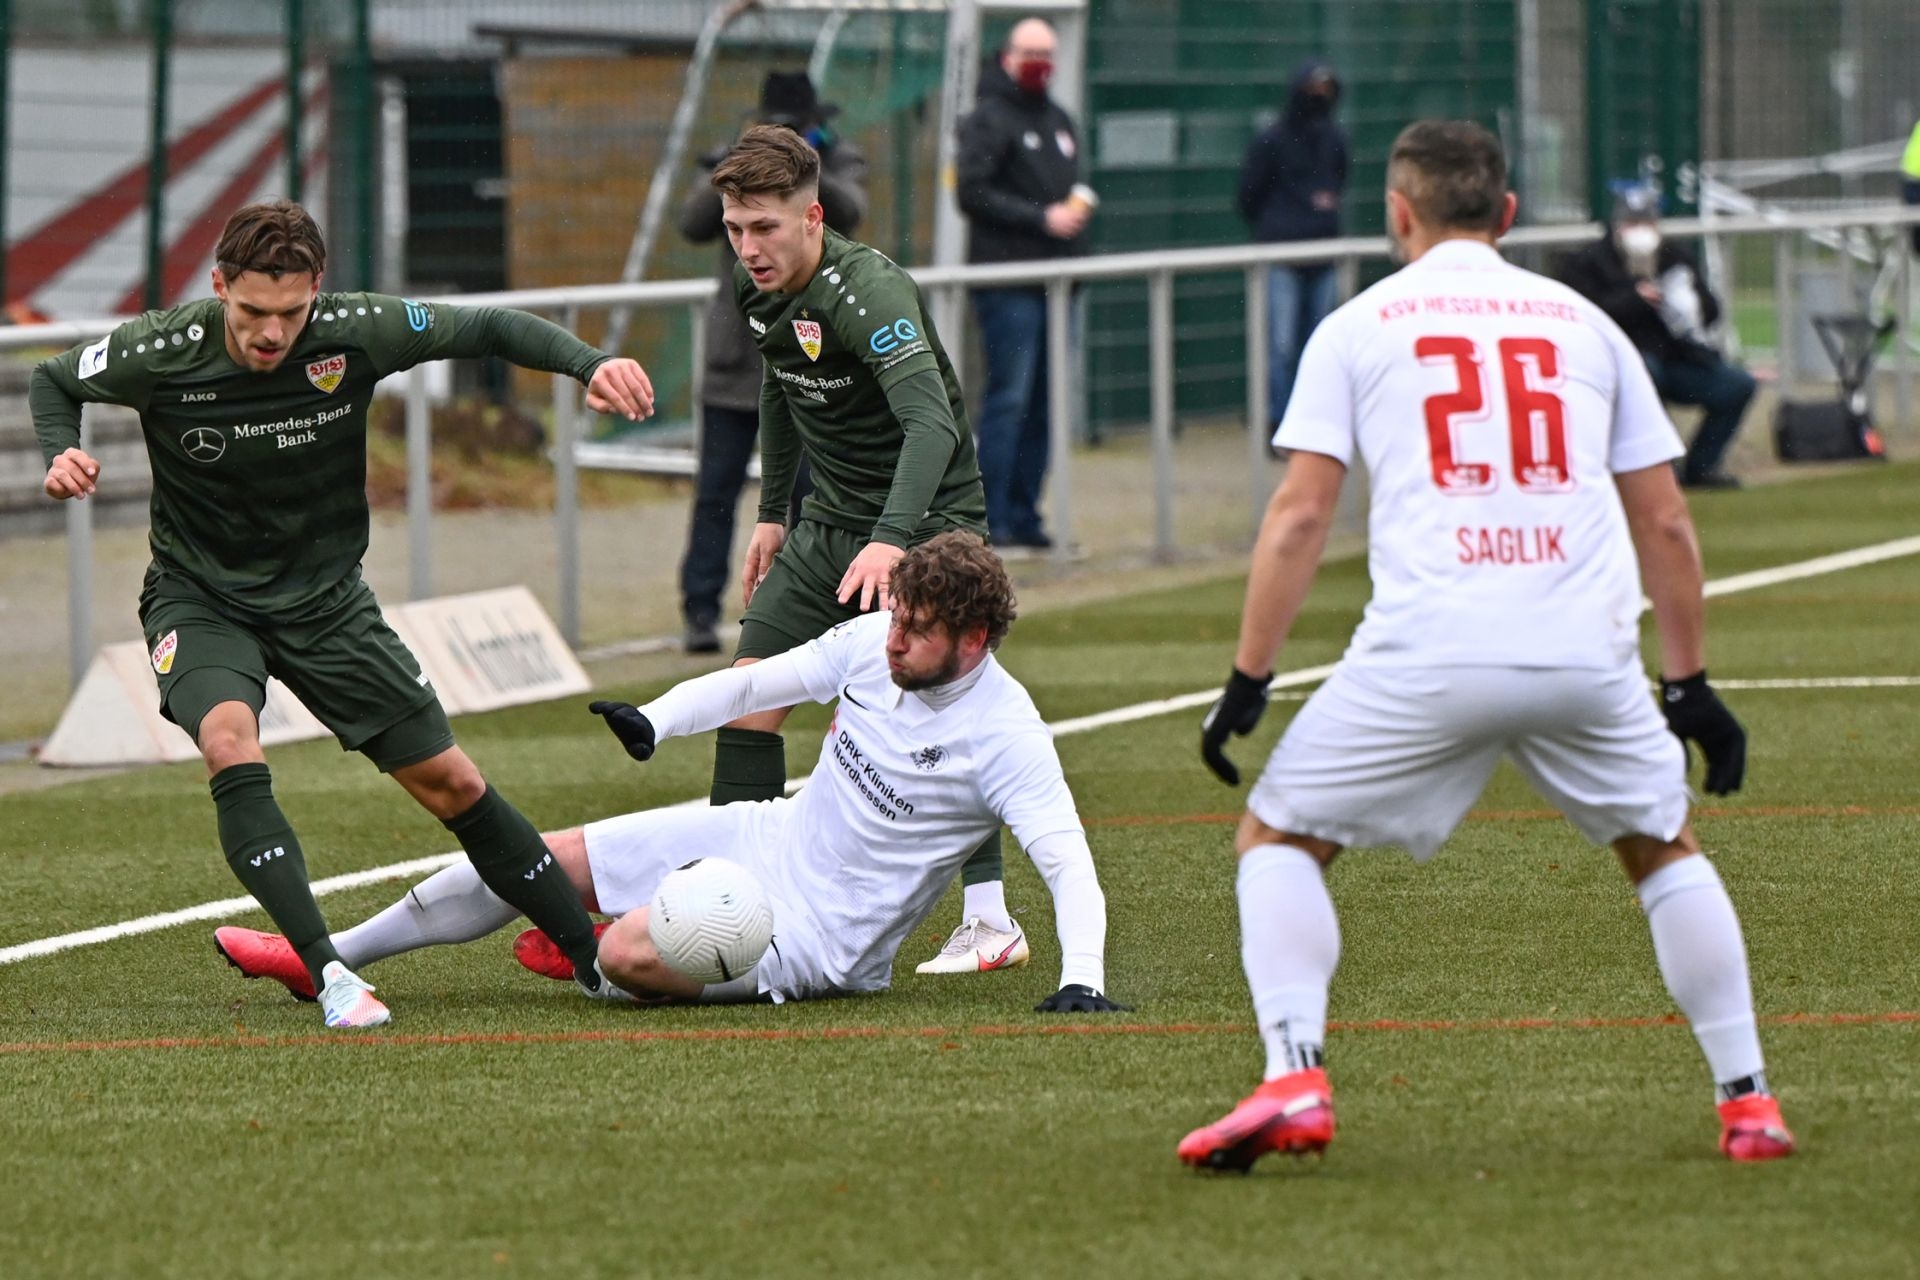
[{"xmin": 1240, "ymin": 61, "xmax": 1348, "ymax": 424}]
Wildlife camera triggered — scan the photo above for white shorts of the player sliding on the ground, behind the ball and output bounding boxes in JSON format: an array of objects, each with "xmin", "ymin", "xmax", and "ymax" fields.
[{"xmin": 584, "ymin": 800, "xmax": 839, "ymax": 1004}]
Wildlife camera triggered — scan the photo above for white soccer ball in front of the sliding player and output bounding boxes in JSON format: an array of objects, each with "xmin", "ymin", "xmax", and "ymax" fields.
[{"xmin": 647, "ymin": 858, "xmax": 774, "ymax": 983}]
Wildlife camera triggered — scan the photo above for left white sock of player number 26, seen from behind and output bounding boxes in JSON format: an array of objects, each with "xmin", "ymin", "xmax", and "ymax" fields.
[{"xmin": 1236, "ymin": 844, "xmax": 1340, "ymax": 1080}]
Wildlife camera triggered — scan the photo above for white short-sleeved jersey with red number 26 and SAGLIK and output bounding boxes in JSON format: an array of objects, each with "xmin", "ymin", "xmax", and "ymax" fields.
[{"xmin": 1273, "ymin": 240, "xmax": 1682, "ymax": 668}]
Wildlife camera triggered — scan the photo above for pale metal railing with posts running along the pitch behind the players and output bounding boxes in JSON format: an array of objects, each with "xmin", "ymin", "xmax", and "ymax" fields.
[{"xmin": 0, "ymin": 205, "xmax": 1920, "ymax": 683}]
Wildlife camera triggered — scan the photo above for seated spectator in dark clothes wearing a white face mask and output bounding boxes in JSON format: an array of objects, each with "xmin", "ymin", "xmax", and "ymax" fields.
[{"xmin": 1561, "ymin": 186, "xmax": 1755, "ymax": 489}]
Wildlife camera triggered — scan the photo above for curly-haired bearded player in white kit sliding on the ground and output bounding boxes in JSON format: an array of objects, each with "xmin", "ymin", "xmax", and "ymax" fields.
[{"xmin": 217, "ymin": 532, "xmax": 1125, "ymax": 1013}]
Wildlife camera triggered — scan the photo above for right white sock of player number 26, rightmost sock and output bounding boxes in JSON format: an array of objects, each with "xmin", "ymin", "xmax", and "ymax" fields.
[{"xmin": 1638, "ymin": 854, "xmax": 1764, "ymax": 1084}]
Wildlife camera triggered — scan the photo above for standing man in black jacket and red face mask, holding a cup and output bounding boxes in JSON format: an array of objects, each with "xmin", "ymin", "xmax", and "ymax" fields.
[{"xmin": 956, "ymin": 17, "xmax": 1092, "ymax": 549}]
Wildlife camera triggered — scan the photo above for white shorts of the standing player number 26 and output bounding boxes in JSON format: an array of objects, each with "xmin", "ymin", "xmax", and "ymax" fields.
[{"xmin": 1246, "ymin": 662, "xmax": 1688, "ymax": 862}]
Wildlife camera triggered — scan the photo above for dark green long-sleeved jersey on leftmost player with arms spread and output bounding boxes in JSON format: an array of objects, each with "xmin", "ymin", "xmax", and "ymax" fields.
[{"xmin": 29, "ymin": 294, "xmax": 607, "ymax": 622}]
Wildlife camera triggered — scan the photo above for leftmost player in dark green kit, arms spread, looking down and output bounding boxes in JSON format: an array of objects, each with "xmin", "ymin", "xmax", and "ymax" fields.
[{"xmin": 29, "ymin": 201, "xmax": 653, "ymax": 1027}]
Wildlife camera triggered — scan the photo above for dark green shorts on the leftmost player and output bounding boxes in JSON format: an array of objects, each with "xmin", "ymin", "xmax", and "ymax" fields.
[{"xmin": 140, "ymin": 570, "xmax": 453, "ymax": 773}]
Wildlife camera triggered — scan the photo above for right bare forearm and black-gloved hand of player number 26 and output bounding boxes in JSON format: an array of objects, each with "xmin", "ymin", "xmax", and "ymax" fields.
[{"xmin": 1613, "ymin": 462, "xmax": 1747, "ymax": 796}]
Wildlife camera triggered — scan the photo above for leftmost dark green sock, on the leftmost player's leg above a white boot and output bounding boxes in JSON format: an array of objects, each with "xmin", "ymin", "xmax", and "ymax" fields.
[{"xmin": 207, "ymin": 764, "xmax": 340, "ymax": 990}]
